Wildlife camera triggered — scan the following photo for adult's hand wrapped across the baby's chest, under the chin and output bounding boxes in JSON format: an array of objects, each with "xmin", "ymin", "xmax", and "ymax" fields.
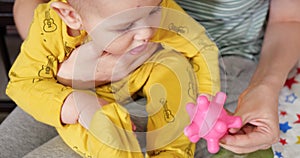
[{"xmin": 57, "ymin": 43, "xmax": 152, "ymax": 89}]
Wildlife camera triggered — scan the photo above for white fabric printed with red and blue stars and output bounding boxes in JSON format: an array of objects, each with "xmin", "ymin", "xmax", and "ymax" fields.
[{"xmin": 273, "ymin": 66, "xmax": 300, "ymax": 158}]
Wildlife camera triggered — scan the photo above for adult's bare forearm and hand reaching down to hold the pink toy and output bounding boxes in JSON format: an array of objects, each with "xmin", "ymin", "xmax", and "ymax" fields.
[{"xmin": 222, "ymin": 0, "xmax": 300, "ymax": 153}]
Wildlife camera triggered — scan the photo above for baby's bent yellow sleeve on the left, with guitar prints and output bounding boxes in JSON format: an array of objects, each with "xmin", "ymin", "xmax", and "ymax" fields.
[{"xmin": 6, "ymin": 4, "xmax": 83, "ymax": 127}]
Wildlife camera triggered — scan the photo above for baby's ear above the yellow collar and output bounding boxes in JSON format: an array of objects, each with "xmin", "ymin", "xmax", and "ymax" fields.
[{"xmin": 50, "ymin": 2, "xmax": 82, "ymax": 30}]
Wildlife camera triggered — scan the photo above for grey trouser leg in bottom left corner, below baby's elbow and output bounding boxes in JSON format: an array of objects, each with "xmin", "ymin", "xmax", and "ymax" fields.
[{"xmin": 0, "ymin": 107, "xmax": 57, "ymax": 158}]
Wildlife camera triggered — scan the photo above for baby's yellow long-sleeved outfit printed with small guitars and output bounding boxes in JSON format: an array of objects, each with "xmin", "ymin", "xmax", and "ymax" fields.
[{"xmin": 6, "ymin": 0, "xmax": 219, "ymax": 157}]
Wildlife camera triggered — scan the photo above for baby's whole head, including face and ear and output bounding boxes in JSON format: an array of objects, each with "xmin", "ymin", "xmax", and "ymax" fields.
[{"xmin": 51, "ymin": 0, "xmax": 161, "ymax": 54}]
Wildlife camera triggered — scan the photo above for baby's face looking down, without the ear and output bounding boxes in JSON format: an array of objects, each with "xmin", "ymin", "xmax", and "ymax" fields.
[{"xmin": 83, "ymin": 0, "xmax": 161, "ymax": 56}]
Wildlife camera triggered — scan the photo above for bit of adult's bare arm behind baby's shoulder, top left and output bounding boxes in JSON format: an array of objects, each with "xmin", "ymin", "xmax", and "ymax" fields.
[{"xmin": 13, "ymin": 0, "xmax": 48, "ymax": 39}]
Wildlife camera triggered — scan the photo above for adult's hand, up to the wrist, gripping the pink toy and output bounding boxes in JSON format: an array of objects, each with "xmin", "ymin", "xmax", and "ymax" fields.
[{"xmin": 220, "ymin": 85, "xmax": 279, "ymax": 153}]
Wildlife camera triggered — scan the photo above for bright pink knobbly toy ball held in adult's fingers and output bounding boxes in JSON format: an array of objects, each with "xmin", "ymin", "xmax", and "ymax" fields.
[{"xmin": 184, "ymin": 92, "xmax": 242, "ymax": 153}]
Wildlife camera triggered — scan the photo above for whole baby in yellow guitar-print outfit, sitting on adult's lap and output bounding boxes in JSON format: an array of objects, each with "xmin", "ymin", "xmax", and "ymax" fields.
[{"xmin": 7, "ymin": 0, "xmax": 219, "ymax": 157}]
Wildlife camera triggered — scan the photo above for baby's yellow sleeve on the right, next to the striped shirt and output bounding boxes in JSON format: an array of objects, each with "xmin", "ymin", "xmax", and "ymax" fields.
[{"xmin": 152, "ymin": 0, "xmax": 220, "ymax": 95}]
